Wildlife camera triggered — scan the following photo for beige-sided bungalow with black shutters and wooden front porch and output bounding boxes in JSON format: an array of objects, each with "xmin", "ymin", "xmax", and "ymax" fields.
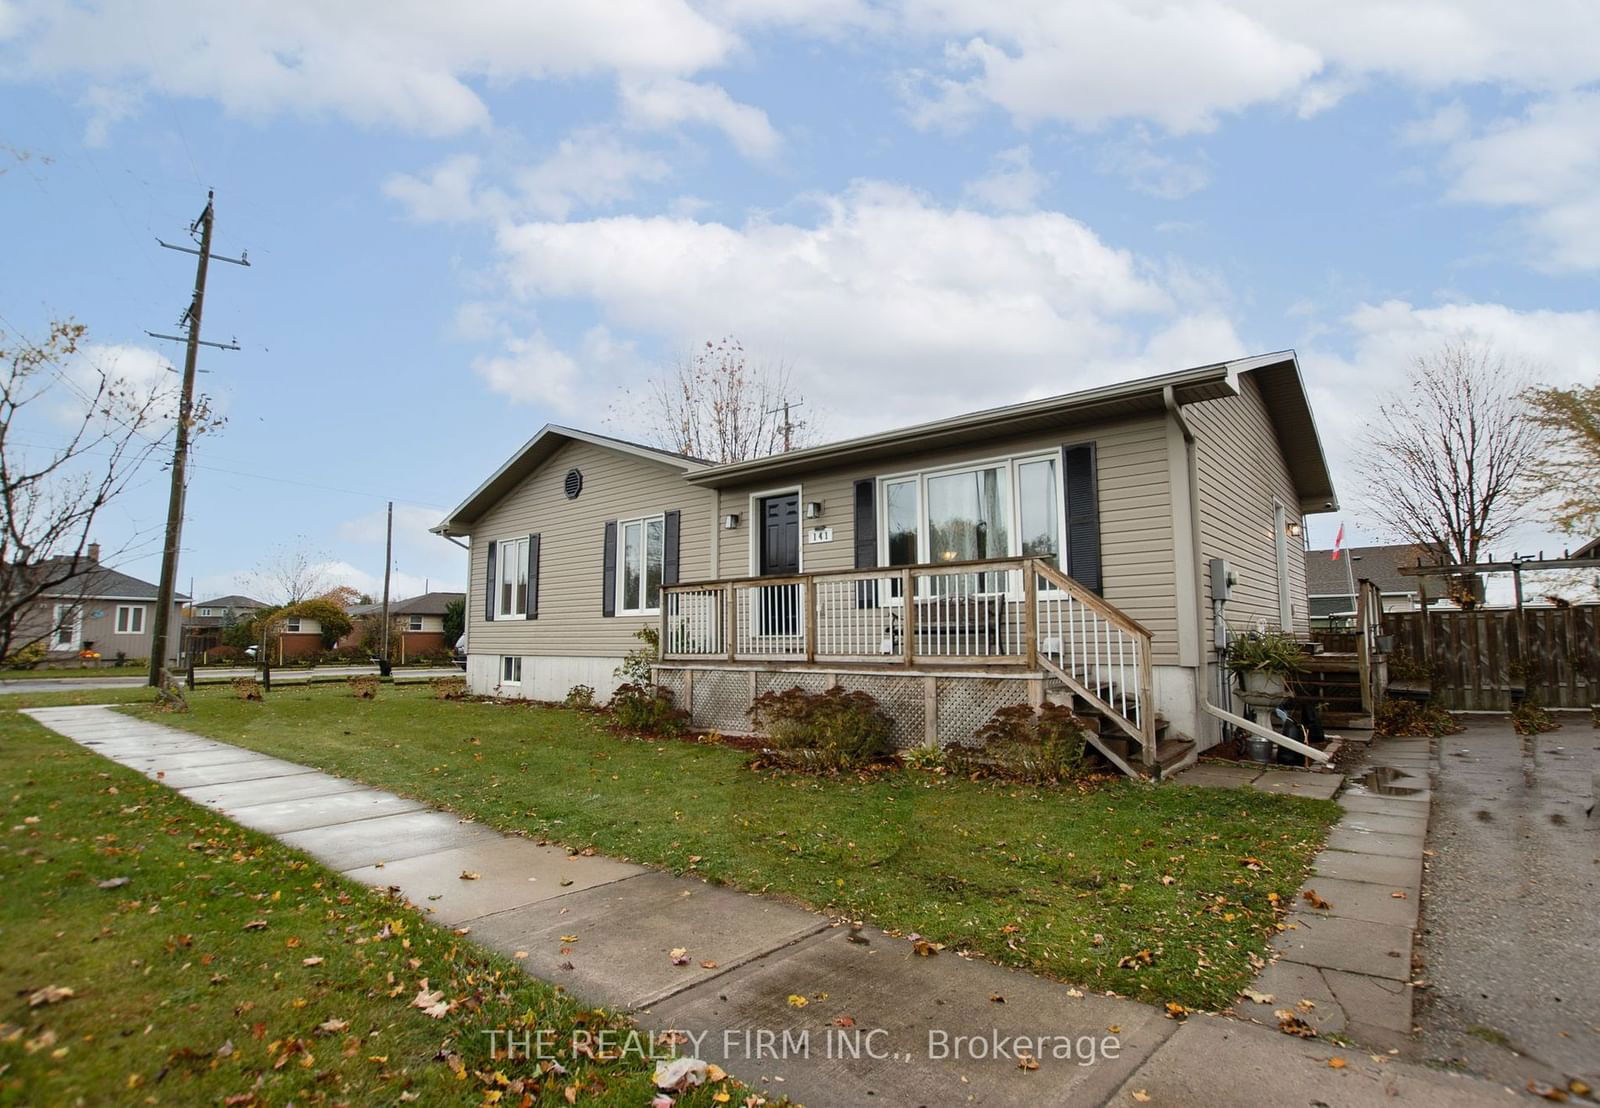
[{"xmin": 435, "ymin": 352, "xmax": 1336, "ymax": 765}]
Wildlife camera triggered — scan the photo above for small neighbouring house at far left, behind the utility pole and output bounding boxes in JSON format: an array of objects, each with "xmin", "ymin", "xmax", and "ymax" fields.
[{"xmin": 9, "ymin": 543, "xmax": 189, "ymax": 663}]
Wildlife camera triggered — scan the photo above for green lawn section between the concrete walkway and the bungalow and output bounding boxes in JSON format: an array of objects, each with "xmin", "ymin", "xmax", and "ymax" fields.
[{"xmin": 128, "ymin": 687, "xmax": 1338, "ymax": 1009}]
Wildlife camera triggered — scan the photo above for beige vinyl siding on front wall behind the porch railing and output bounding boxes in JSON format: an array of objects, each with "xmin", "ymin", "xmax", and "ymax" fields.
[{"xmin": 707, "ymin": 416, "xmax": 1178, "ymax": 664}]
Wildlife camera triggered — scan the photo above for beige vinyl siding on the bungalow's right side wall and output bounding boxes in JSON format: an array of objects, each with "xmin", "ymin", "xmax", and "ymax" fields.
[{"xmin": 1184, "ymin": 373, "xmax": 1310, "ymax": 631}]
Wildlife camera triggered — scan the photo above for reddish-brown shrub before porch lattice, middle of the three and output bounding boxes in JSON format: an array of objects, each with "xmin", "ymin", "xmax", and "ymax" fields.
[{"xmin": 750, "ymin": 685, "xmax": 894, "ymax": 770}]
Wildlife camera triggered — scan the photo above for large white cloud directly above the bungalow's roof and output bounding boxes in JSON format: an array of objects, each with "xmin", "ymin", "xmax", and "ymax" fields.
[{"xmin": 480, "ymin": 183, "xmax": 1242, "ymax": 434}]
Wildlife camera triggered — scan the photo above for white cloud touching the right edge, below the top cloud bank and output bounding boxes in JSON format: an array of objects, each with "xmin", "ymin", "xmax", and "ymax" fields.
[{"xmin": 1445, "ymin": 91, "xmax": 1600, "ymax": 271}]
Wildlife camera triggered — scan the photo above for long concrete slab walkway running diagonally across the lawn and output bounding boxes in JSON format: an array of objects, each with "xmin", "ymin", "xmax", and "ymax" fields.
[{"xmin": 27, "ymin": 708, "xmax": 1512, "ymax": 1108}]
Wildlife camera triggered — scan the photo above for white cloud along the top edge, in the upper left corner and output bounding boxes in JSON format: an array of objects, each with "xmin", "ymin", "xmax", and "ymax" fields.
[{"xmin": 0, "ymin": 0, "xmax": 738, "ymax": 134}]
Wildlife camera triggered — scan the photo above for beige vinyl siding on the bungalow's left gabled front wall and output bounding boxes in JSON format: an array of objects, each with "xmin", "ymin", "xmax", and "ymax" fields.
[{"xmin": 467, "ymin": 442, "xmax": 714, "ymax": 658}]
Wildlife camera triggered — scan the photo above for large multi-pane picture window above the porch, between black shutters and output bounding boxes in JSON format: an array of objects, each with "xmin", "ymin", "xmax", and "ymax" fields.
[{"xmin": 878, "ymin": 452, "xmax": 1066, "ymax": 582}]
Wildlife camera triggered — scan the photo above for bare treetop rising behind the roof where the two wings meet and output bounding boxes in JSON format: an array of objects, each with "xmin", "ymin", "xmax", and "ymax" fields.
[{"xmin": 617, "ymin": 336, "xmax": 816, "ymax": 461}]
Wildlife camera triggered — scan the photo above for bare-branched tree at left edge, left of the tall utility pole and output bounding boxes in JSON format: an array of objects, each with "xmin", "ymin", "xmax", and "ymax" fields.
[{"xmin": 0, "ymin": 320, "xmax": 175, "ymax": 658}]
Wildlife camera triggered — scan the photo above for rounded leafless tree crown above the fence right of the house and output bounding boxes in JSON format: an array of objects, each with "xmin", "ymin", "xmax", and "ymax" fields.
[{"xmin": 1358, "ymin": 339, "xmax": 1542, "ymax": 579}]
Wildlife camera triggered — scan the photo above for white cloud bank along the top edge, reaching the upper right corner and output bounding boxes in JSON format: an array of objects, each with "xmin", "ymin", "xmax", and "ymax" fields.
[{"xmin": 899, "ymin": 0, "xmax": 1600, "ymax": 133}]
